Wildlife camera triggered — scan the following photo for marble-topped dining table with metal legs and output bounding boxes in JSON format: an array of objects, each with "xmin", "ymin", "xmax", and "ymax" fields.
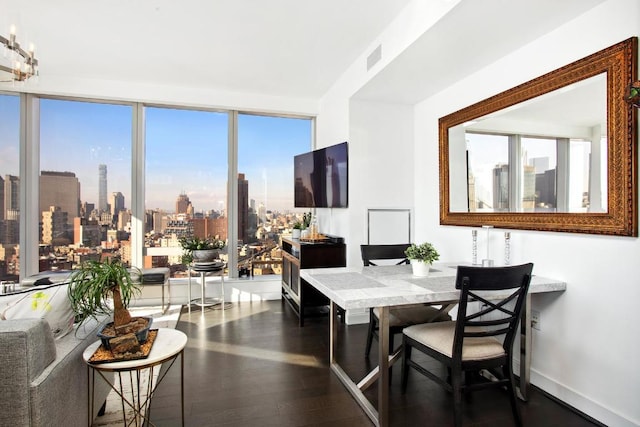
[{"xmin": 300, "ymin": 262, "xmax": 566, "ymax": 427}]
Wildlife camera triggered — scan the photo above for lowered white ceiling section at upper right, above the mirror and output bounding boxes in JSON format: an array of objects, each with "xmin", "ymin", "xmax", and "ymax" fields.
[{"xmin": 356, "ymin": 0, "xmax": 605, "ymax": 104}]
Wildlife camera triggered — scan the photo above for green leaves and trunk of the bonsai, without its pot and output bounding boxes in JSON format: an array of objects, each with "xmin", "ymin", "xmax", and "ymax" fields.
[{"xmin": 69, "ymin": 259, "xmax": 141, "ymax": 330}]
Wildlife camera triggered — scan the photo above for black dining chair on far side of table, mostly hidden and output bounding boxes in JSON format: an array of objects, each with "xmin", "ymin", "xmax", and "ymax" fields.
[{"xmin": 360, "ymin": 243, "xmax": 451, "ymax": 357}]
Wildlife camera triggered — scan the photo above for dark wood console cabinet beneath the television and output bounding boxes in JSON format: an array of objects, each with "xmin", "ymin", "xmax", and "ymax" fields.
[{"xmin": 282, "ymin": 236, "xmax": 347, "ymax": 326}]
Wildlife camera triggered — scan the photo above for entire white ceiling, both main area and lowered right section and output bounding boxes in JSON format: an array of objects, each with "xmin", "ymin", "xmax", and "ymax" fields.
[{"xmin": 0, "ymin": 0, "xmax": 605, "ymax": 104}]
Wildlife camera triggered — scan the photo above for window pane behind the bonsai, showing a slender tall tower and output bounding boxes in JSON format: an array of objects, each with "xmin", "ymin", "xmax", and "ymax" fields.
[{"xmin": 38, "ymin": 98, "xmax": 132, "ymax": 271}]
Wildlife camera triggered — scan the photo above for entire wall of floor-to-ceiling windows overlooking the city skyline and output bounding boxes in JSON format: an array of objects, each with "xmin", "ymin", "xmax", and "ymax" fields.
[{"xmin": 5, "ymin": 95, "xmax": 313, "ymax": 280}]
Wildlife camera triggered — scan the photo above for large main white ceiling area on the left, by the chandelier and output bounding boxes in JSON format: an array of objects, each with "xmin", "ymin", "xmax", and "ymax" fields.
[{"xmin": 0, "ymin": 0, "xmax": 410, "ymax": 99}]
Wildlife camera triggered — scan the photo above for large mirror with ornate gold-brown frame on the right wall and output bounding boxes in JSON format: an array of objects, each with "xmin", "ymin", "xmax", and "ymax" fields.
[{"xmin": 439, "ymin": 37, "xmax": 638, "ymax": 236}]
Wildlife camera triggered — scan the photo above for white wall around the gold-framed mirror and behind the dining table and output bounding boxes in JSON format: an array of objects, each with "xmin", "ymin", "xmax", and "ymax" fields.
[{"xmin": 318, "ymin": 0, "xmax": 640, "ymax": 426}]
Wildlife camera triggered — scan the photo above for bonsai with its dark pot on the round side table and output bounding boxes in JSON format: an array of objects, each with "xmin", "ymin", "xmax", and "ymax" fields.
[{"xmin": 68, "ymin": 258, "xmax": 152, "ymax": 349}]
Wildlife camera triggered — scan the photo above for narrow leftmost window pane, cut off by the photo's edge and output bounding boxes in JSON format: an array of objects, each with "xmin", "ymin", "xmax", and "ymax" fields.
[{"xmin": 0, "ymin": 94, "xmax": 20, "ymax": 281}]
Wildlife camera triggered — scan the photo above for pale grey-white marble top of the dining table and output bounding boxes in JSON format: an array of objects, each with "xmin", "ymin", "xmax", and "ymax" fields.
[{"xmin": 300, "ymin": 263, "xmax": 567, "ymax": 310}]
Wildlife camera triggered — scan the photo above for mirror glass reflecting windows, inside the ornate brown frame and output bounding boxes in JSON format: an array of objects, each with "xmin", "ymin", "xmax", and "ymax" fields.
[{"xmin": 449, "ymin": 73, "xmax": 607, "ymax": 213}]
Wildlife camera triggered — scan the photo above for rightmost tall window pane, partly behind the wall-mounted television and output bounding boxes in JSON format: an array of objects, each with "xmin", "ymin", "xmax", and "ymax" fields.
[{"xmin": 238, "ymin": 114, "xmax": 312, "ymax": 275}]
